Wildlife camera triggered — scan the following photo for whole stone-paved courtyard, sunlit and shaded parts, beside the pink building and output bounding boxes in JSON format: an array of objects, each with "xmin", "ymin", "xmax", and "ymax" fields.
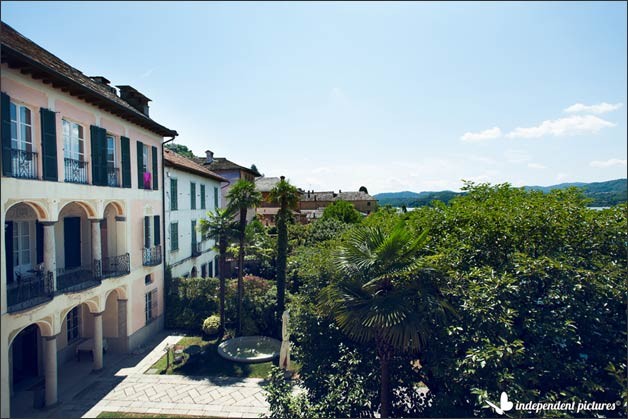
[{"xmin": 14, "ymin": 336, "xmax": 268, "ymax": 418}]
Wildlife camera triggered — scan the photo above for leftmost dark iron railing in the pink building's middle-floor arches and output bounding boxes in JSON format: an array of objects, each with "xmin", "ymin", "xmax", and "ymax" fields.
[{"xmin": 7, "ymin": 271, "xmax": 54, "ymax": 313}]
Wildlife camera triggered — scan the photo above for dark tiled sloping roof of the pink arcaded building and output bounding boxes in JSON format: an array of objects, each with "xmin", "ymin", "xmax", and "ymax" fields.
[{"xmin": 0, "ymin": 22, "xmax": 177, "ymax": 137}]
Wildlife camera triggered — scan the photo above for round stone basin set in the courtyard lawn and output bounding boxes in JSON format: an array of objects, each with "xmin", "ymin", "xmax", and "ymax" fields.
[{"xmin": 218, "ymin": 336, "xmax": 281, "ymax": 363}]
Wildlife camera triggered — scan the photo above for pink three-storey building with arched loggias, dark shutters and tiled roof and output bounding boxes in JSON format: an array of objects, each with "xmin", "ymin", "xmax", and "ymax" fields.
[{"xmin": 0, "ymin": 23, "xmax": 176, "ymax": 417}]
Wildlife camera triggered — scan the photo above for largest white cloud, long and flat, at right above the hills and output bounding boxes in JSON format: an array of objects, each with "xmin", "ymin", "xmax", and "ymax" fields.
[{"xmin": 506, "ymin": 115, "xmax": 615, "ymax": 138}]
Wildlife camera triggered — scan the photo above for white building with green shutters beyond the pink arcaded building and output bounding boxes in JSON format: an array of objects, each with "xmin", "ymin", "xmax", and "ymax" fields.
[{"xmin": 164, "ymin": 148, "xmax": 227, "ymax": 278}]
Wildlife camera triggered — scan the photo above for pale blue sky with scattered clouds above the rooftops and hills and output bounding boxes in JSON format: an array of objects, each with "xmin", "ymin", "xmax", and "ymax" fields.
[{"xmin": 2, "ymin": 1, "xmax": 628, "ymax": 193}]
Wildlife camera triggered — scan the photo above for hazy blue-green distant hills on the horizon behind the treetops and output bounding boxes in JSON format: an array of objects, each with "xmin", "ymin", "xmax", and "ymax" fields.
[{"xmin": 375, "ymin": 179, "xmax": 628, "ymax": 208}]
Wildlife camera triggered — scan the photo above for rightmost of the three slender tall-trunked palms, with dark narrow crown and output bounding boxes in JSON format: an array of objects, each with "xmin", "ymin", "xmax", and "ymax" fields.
[{"xmin": 268, "ymin": 176, "xmax": 301, "ymax": 330}]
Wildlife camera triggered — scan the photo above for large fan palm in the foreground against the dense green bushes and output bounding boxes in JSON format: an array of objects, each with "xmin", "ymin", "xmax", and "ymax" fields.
[{"xmin": 320, "ymin": 225, "xmax": 449, "ymax": 418}]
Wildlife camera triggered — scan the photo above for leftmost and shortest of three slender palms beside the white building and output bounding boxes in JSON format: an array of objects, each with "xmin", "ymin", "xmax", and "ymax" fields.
[{"xmin": 198, "ymin": 208, "xmax": 238, "ymax": 335}]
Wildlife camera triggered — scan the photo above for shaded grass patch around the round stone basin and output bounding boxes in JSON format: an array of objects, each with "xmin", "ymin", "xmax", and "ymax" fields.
[{"xmin": 148, "ymin": 336, "xmax": 278, "ymax": 380}]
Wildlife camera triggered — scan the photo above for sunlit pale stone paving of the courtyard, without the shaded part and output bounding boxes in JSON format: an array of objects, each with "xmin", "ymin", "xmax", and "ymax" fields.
[{"xmin": 83, "ymin": 336, "xmax": 268, "ymax": 418}]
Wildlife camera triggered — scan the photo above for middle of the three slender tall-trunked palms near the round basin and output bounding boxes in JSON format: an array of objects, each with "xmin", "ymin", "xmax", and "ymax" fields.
[{"xmin": 227, "ymin": 179, "xmax": 262, "ymax": 336}]
